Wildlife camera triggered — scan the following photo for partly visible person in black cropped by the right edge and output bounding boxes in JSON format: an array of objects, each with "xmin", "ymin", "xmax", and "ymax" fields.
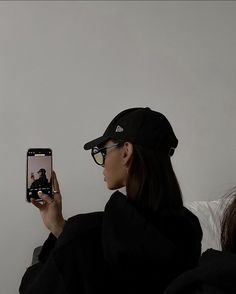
[{"xmin": 164, "ymin": 187, "xmax": 236, "ymax": 294}]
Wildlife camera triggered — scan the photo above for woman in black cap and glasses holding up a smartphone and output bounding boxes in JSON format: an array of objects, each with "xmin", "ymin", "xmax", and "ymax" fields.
[{"xmin": 20, "ymin": 108, "xmax": 202, "ymax": 294}]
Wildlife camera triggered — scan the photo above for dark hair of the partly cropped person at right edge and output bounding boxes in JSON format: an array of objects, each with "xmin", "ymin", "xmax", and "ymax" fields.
[{"xmin": 221, "ymin": 187, "xmax": 236, "ymax": 253}]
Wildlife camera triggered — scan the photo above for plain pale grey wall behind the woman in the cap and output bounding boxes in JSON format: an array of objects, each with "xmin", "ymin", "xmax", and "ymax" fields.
[{"xmin": 0, "ymin": 1, "xmax": 236, "ymax": 294}]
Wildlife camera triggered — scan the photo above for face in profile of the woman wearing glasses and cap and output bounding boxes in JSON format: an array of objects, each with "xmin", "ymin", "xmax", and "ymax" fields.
[{"xmin": 103, "ymin": 141, "xmax": 130, "ymax": 190}]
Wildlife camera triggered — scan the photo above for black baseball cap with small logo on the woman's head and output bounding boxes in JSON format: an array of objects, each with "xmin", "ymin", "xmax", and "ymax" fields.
[{"xmin": 84, "ymin": 107, "xmax": 178, "ymax": 155}]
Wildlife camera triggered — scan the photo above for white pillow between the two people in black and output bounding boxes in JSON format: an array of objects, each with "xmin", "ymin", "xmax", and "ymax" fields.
[{"xmin": 184, "ymin": 199, "xmax": 227, "ymax": 252}]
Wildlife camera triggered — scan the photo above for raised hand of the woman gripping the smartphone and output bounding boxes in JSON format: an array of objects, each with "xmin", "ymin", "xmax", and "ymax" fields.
[{"xmin": 31, "ymin": 172, "xmax": 65, "ymax": 238}]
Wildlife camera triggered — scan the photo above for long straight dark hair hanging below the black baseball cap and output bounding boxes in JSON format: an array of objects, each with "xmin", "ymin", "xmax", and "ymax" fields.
[{"xmin": 126, "ymin": 145, "xmax": 183, "ymax": 211}]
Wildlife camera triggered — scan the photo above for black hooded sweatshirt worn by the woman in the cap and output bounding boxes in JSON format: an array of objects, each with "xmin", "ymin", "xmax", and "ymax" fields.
[{"xmin": 20, "ymin": 191, "xmax": 202, "ymax": 294}]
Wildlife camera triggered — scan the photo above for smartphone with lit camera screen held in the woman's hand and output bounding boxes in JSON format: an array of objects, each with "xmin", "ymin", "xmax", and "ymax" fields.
[{"xmin": 26, "ymin": 148, "xmax": 53, "ymax": 202}]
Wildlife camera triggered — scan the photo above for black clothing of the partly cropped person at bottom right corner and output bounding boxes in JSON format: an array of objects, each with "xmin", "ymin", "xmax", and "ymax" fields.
[{"xmin": 164, "ymin": 249, "xmax": 236, "ymax": 294}]
